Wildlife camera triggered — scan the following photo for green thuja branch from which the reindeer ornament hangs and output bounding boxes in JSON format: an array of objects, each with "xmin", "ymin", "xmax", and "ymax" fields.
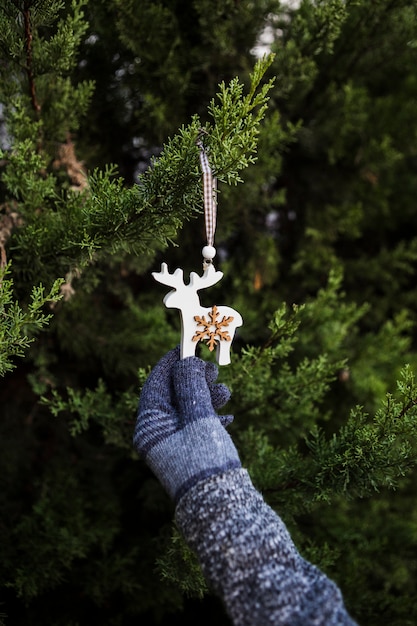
[{"xmin": 8, "ymin": 53, "xmax": 271, "ymax": 282}]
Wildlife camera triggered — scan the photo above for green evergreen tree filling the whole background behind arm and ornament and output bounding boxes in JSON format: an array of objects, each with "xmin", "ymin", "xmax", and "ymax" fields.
[{"xmin": 0, "ymin": 0, "xmax": 417, "ymax": 626}]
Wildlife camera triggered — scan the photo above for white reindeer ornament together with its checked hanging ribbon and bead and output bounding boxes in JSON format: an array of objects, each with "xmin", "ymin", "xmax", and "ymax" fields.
[{"xmin": 152, "ymin": 134, "xmax": 243, "ymax": 365}]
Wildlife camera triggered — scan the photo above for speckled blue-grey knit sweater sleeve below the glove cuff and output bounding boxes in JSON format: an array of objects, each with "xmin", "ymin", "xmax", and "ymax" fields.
[{"xmin": 176, "ymin": 469, "xmax": 355, "ymax": 626}]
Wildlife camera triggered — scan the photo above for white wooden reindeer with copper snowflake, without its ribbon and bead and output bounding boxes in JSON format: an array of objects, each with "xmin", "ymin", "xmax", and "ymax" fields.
[{"xmin": 152, "ymin": 263, "xmax": 243, "ymax": 365}]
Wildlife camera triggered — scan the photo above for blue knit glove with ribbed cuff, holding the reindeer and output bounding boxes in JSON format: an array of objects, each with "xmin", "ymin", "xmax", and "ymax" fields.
[{"xmin": 133, "ymin": 348, "xmax": 241, "ymax": 502}]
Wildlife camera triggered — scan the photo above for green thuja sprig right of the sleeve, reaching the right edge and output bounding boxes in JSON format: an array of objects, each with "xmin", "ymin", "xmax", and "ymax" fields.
[{"xmin": 237, "ymin": 366, "xmax": 417, "ymax": 515}]
